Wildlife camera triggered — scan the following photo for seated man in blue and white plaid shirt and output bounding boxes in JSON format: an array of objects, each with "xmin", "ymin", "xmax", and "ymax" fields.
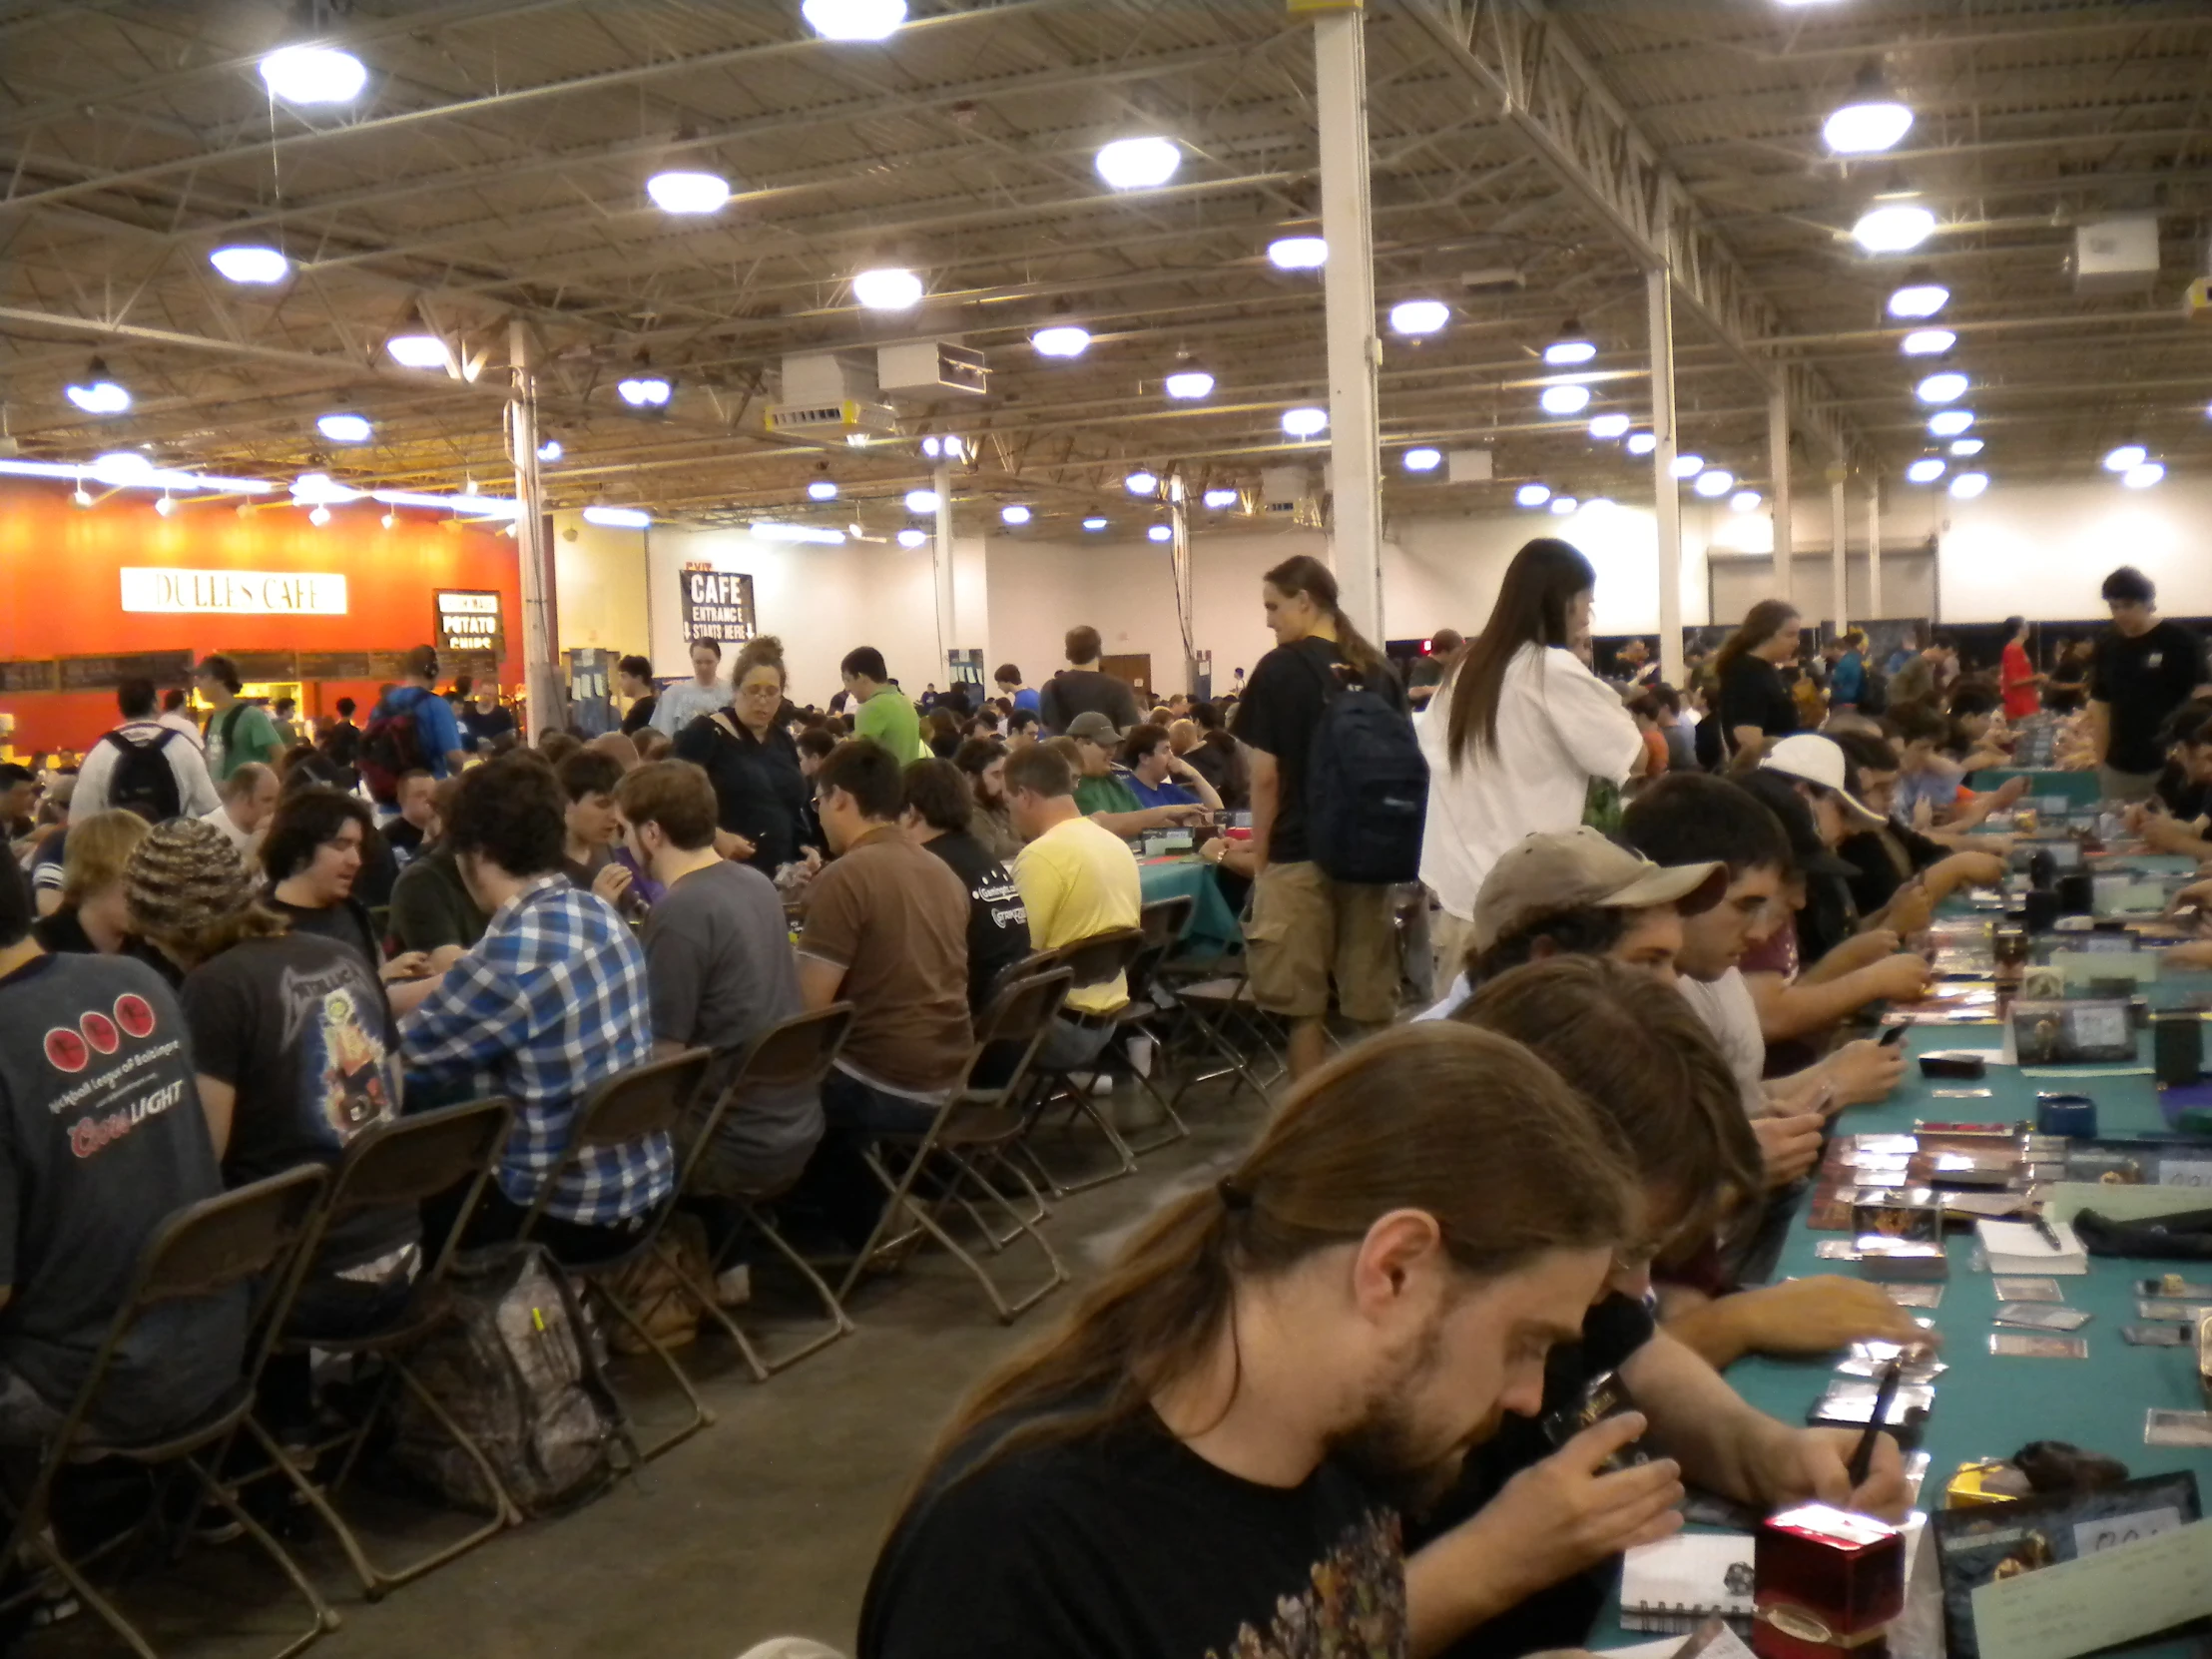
[{"xmin": 400, "ymin": 759, "xmax": 675, "ymax": 1261}]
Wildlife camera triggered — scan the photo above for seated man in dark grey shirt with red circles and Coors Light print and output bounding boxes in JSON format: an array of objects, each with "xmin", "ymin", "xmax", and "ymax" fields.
[{"xmin": 0, "ymin": 858, "xmax": 246, "ymax": 1453}]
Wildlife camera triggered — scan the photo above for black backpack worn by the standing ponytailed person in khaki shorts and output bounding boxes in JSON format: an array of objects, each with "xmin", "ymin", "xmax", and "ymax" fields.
[{"xmin": 1305, "ymin": 657, "xmax": 1429, "ymax": 884}]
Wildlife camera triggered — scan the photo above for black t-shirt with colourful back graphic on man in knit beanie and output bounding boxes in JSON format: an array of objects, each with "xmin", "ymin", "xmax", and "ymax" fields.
[{"xmin": 184, "ymin": 933, "xmax": 416, "ymax": 1270}]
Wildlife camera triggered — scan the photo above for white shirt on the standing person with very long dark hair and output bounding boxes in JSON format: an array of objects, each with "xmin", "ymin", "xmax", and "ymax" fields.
[{"xmin": 1415, "ymin": 646, "xmax": 1643, "ymax": 920}]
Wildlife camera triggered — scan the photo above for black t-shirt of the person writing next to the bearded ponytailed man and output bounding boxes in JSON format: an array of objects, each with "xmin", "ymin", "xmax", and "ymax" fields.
[{"xmin": 1406, "ymin": 1292, "xmax": 1659, "ymax": 1659}]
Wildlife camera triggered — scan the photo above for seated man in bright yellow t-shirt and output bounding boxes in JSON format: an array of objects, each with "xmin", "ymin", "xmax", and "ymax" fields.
[{"xmin": 1006, "ymin": 743, "xmax": 1144, "ymax": 1073}]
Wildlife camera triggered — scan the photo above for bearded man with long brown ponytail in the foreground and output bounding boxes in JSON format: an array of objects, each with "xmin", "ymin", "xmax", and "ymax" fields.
[{"xmin": 858, "ymin": 1022, "xmax": 1643, "ymax": 1659}]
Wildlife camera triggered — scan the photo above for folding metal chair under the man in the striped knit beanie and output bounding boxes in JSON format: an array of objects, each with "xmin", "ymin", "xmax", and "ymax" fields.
[{"xmin": 246, "ymin": 1099, "xmax": 522, "ymax": 1601}]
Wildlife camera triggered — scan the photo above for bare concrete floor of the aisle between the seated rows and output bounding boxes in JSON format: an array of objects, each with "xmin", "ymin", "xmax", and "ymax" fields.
[{"xmin": 43, "ymin": 1086, "xmax": 1261, "ymax": 1659}]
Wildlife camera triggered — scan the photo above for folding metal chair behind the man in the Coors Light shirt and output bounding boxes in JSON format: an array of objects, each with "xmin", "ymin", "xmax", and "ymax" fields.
[{"xmin": 0, "ymin": 1166, "xmax": 338, "ymax": 1659}]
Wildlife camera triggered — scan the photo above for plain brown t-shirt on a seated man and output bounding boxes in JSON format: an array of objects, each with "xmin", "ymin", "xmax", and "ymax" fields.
[{"xmin": 799, "ymin": 826, "xmax": 975, "ymax": 1097}]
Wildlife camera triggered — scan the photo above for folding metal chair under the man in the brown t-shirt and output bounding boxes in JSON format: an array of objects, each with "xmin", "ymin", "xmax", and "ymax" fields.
[{"xmin": 838, "ymin": 966, "xmax": 1073, "ymax": 1325}]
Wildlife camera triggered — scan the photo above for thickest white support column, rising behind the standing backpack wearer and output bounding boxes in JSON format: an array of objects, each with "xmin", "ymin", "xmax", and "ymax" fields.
[{"xmin": 1314, "ymin": 7, "xmax": 1382, "ymax": 646}]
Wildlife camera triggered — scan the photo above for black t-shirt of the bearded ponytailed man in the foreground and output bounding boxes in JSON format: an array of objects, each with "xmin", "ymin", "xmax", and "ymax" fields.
[{"xmin": 858, "ymin": 1413, "xmax": 1406, "ymax": 1659}]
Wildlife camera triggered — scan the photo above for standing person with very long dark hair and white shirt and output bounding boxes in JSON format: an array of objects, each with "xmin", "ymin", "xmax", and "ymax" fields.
[{"xmin": 1415, "ymin": 535, "xmax": 1643, "ymax": 984}]
